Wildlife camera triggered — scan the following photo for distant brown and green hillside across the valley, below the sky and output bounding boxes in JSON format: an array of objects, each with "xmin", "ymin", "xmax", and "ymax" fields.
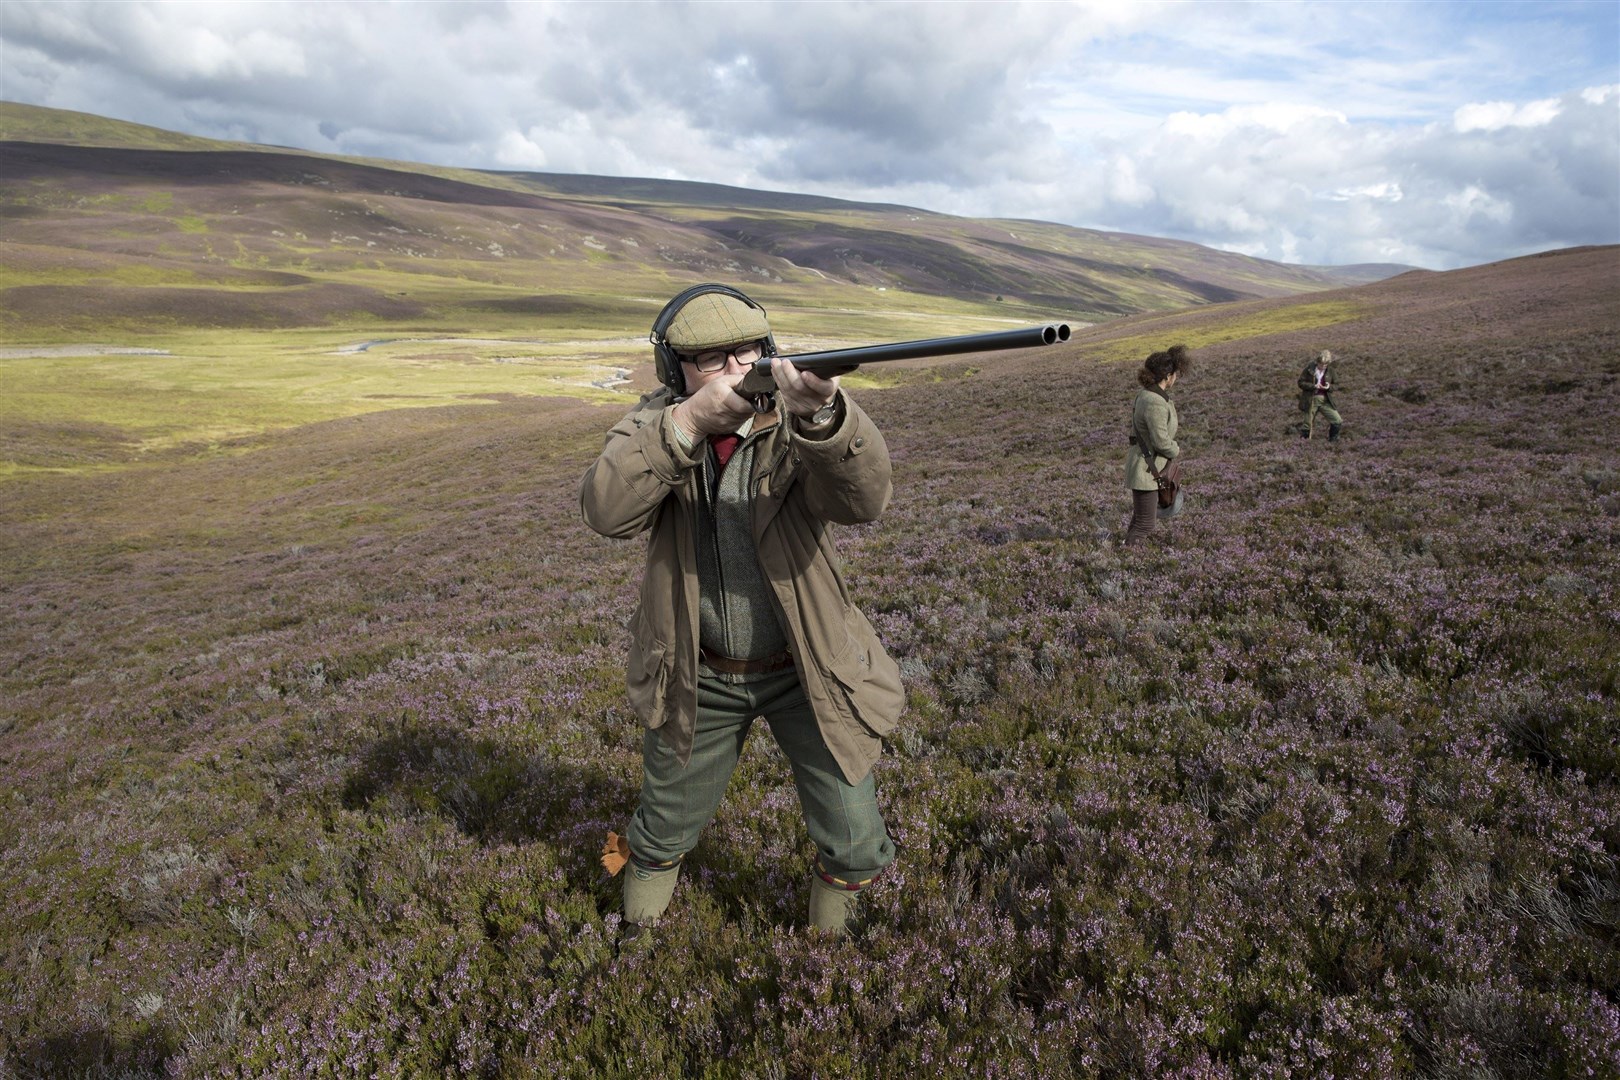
[{"xmin": 0, "ymin": 104, "xmax": 1409, "ymax": 337}]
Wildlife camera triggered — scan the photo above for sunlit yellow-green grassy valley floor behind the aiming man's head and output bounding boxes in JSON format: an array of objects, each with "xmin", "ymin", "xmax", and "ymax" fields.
[{"xmin": 0, "ymin": 241, "xmax": 1088, "ymax": 478}]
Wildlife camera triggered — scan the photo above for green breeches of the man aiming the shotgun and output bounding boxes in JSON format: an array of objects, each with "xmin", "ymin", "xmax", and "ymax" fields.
[{"xmin": 629, "ymin": 669, "xmax": 894, "ymax": 887}]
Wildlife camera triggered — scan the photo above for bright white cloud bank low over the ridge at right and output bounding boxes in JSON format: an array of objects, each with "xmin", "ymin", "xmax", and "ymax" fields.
[{"xmin": 1042, "ymin": 82, "xmax": 1620, "ymax": 267}]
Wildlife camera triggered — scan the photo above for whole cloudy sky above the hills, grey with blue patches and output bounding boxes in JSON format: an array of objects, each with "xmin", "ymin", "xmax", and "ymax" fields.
[{"xmin": 0, "ymin": 0, "xmax": 1620, "ymax": 269}]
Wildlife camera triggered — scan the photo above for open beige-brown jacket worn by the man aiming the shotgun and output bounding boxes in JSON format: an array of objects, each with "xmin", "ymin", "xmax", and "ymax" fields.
[{"xmin": 580, "ymin": 389, "xmax": 906, "ymax": 784}]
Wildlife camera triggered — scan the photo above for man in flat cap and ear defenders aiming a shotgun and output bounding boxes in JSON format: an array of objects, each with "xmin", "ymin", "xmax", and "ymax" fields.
[{"xmin": 580, "ymin": 285, "xmax": 906, "ymax": 936}]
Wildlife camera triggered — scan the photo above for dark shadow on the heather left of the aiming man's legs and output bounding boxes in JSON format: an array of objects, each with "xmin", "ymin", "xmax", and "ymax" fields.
[{"xmin": 342, "ymin": 729, "xmax": 640, "ymax": 844}]
